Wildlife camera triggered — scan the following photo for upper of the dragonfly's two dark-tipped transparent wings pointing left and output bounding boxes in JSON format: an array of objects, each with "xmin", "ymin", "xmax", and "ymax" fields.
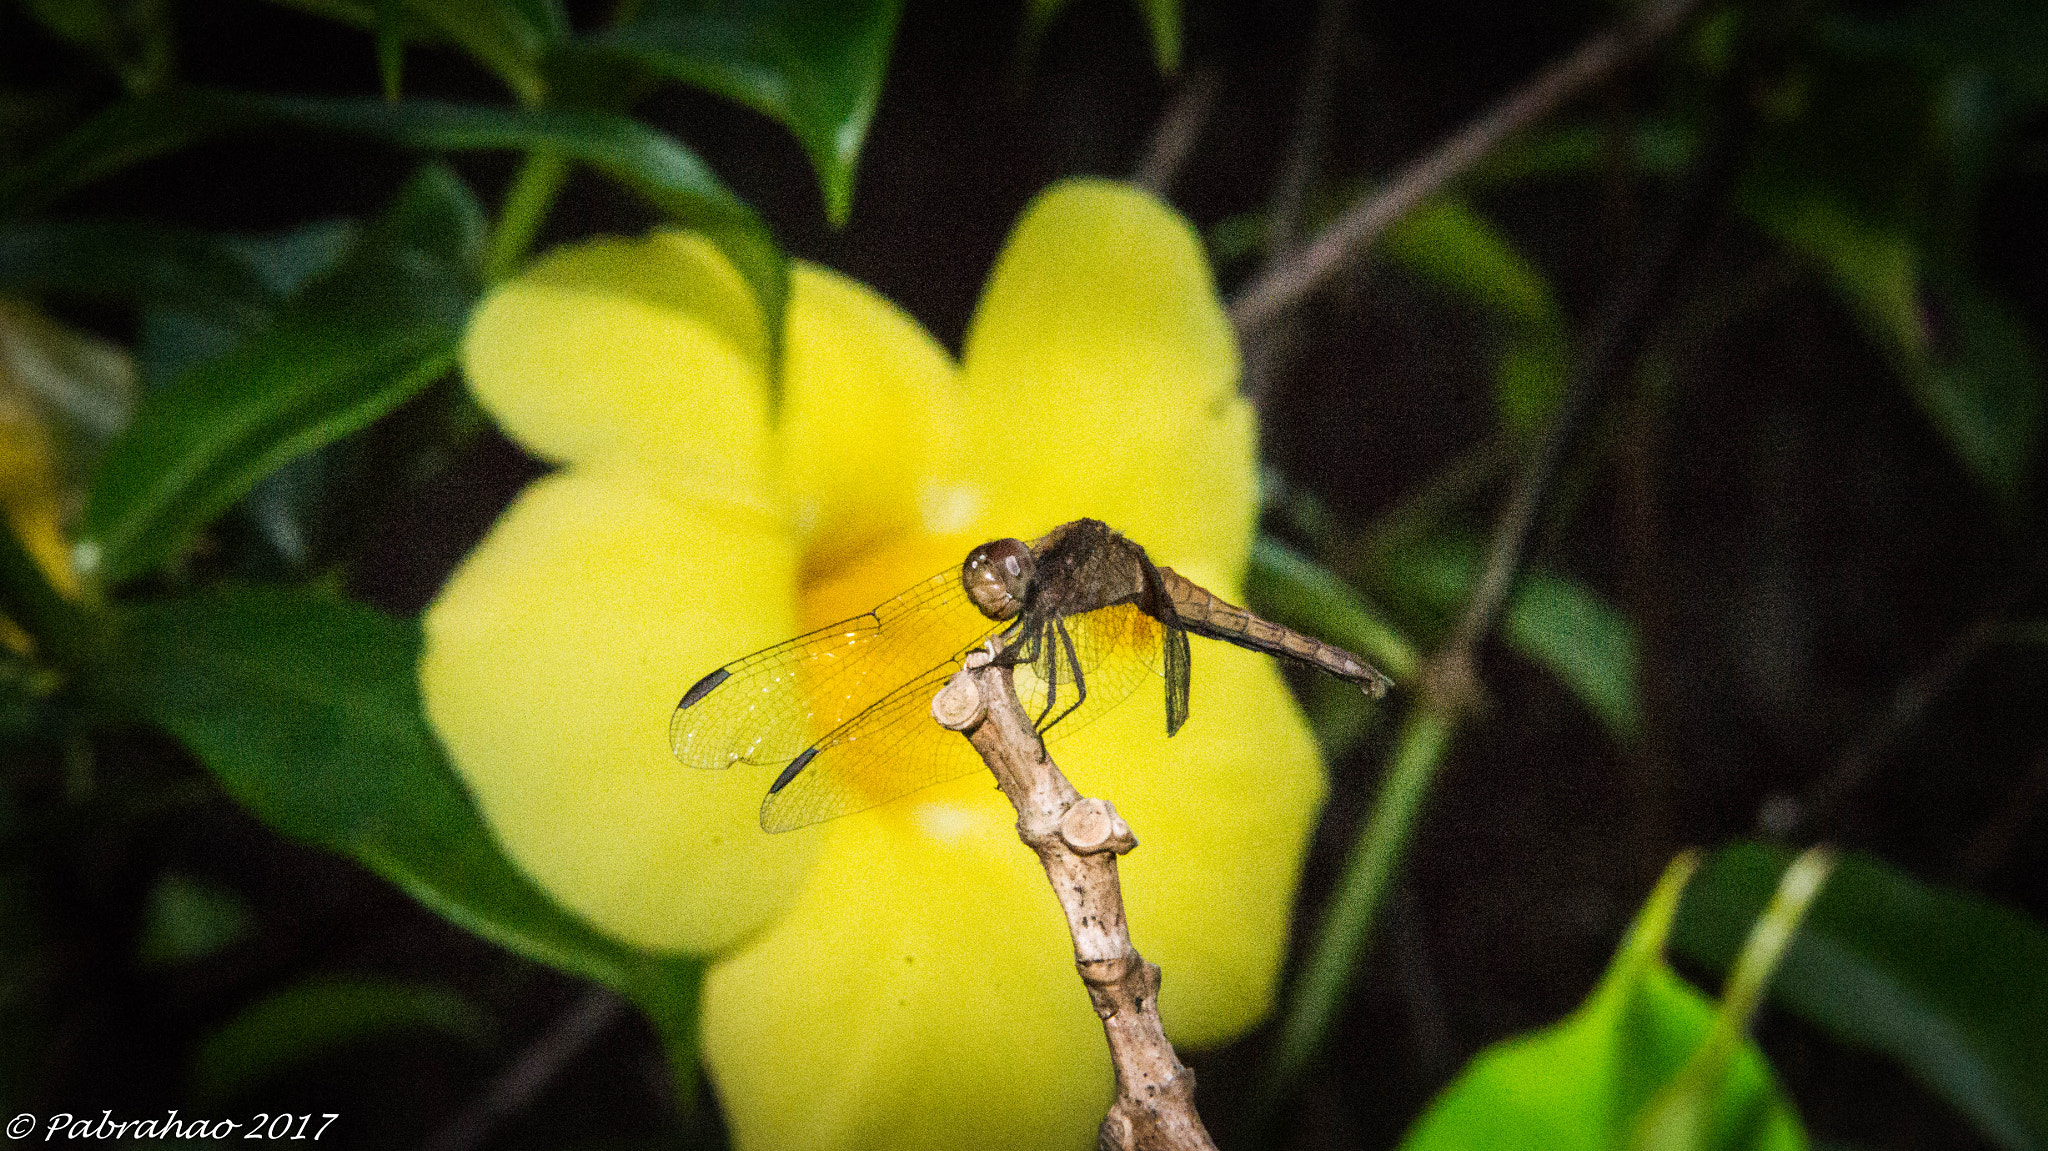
[{"xmin": 668, "ymin": 567, "xmax": 1001, "ymax": 768}]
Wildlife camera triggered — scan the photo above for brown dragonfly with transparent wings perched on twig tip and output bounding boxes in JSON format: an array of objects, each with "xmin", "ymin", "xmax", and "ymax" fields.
[{"xmin": 668, "ymin": 520, "xmax": 1389, "ymax": 832}]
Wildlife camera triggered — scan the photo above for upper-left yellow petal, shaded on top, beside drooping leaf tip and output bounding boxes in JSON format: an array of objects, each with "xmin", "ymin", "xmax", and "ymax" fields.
[{"xmin": 463, "ymin": 231, "xmax": 768, "ymax": 506}]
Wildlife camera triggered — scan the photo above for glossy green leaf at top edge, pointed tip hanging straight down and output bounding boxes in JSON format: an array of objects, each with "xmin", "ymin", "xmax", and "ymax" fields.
[{"xmin": 569, "ymin": 0, "xmax": 903, "ymax": 225}]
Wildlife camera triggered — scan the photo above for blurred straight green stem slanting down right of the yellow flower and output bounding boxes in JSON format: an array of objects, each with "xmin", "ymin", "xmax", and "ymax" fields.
[{"xmin": 1253, "ymin": 705, "xmax": 1456, "ymax": 1105}]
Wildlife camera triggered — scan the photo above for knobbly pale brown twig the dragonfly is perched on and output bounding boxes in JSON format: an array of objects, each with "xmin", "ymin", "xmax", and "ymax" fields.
[{"xmin": 932, "ymin": 651, "xmax": 1217, "ymax": 1151}]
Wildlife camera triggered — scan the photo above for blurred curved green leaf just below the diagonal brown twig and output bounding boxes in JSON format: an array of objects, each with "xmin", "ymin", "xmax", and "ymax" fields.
[{"xmin": 1380, "ymin": 197, "xmax": 1571, "ymax": 436}]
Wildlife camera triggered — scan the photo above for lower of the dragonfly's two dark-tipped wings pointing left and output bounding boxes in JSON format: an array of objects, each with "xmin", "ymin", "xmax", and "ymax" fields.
[{"xmin": 762, "ymin": 659, "xmax": 981, "ymax": 832}]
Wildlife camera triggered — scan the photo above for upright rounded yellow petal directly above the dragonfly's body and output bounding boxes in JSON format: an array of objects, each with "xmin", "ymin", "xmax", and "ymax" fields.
[{"xmin": 963, "ymin": 180, "xmax": 1257, "ymax": 565}]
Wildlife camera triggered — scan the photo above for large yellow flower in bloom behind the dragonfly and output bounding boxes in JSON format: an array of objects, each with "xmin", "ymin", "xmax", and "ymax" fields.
[{"xmin": 420, "ymin": 180, "xmax": 1323, "ymax": 1151}]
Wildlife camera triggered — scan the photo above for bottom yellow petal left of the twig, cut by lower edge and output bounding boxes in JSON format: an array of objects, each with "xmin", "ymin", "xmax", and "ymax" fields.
[{"xmin": 705, "ymin": 798, "xmax": 1110, "ymax": 1151}]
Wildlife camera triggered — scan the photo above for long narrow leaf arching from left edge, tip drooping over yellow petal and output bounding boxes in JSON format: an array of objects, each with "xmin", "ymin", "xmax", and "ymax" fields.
[{"xmin": 0, "ymin": 88, "xmax": 788, "ymax": 340}]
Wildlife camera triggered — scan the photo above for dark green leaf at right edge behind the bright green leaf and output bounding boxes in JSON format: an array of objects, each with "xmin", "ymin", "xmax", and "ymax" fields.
[{"xmin": 1673, "ymin": 844, "xmax": 2048, "ymax": 1151}]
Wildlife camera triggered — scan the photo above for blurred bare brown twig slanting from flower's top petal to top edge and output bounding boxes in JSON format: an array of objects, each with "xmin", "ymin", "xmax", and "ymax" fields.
[{"xmin": 1231, "ymin": 0, "xmax": 1700, "ymax": 338}]
